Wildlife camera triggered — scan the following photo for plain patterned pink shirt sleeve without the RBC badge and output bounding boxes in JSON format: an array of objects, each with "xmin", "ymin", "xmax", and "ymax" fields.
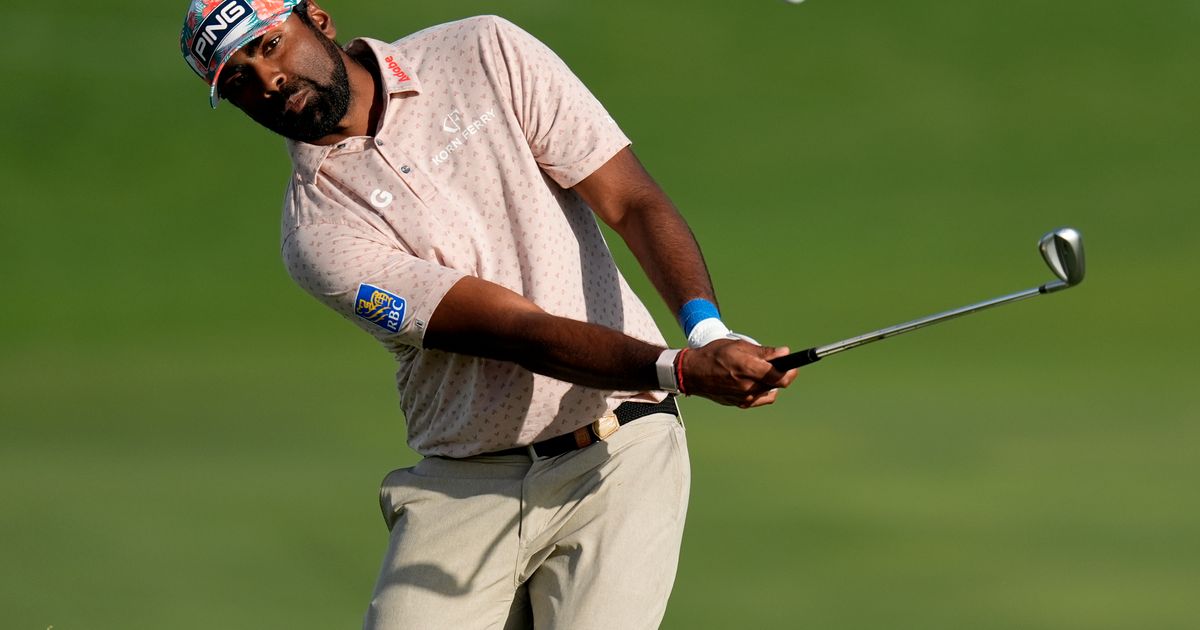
[{"xmin": 485, "ymin": 17, "xmax": 630, "ymax": 188}]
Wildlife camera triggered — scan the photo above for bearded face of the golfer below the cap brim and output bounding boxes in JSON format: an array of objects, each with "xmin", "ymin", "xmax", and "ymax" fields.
[{"xmin": 217, "ymin": 14, "xmax": 350, "ymax": 142}]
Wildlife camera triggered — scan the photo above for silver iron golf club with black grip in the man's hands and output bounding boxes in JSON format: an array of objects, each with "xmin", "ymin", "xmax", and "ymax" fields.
[{"xmin": 770, "ymin": 228, "xmax": 1084, "ymax": 370}]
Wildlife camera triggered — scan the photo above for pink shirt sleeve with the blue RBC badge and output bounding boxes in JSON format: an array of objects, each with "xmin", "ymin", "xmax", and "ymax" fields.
[{"xmin": 283, "ymin": 223, "xmax": 463, "ymax": 350}]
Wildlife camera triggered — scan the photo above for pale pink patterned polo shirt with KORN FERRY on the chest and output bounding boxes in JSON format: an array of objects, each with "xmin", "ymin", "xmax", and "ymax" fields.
[{"xmin": 282, "ymin": 17, "xmax": 665, "ymax": 457}]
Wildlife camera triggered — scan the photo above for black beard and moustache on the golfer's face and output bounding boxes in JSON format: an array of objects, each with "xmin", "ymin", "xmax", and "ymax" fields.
[{"xmin": 253, "ymin": 34, "xmax": 350, "ymax": 143}]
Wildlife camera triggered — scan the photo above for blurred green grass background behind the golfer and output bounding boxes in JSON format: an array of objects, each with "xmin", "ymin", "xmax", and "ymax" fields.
[{"xmin": 0, "ymin": 0, "xmax": 1200, "ymax": 630}]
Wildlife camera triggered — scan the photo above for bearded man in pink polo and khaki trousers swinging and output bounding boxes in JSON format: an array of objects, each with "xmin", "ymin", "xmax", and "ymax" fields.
[{"xmin": 181, "ymin": 0, "xmax": 796, "ymax": 629}]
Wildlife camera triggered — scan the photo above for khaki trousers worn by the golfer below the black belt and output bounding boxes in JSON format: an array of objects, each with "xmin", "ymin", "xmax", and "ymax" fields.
[{"xmin": 364, "ymin": 414, "xmax": 691, "ymax": 630}]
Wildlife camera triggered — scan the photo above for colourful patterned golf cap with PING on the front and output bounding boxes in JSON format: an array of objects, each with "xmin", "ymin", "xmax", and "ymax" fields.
[{"xmin": 179, "ymin": 0, "xmax": 304, "ymax": 108}]
